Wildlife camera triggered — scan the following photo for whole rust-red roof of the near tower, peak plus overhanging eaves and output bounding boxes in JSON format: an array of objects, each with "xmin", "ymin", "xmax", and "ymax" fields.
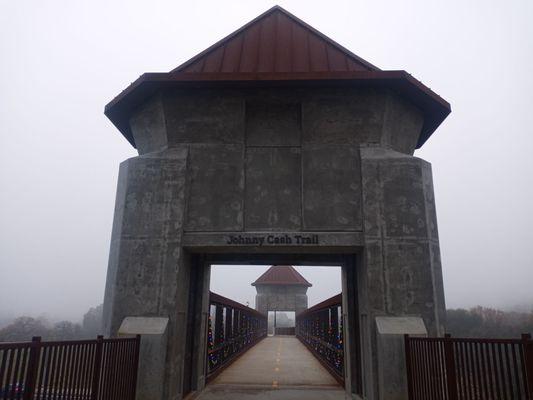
[{"xmin": 105, "ymin": 6, "xmax": 451, "ymax": 148}]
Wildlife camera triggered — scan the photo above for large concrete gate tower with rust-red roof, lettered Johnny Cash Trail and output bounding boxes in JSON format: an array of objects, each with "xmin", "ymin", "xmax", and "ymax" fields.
[{"xmin": 104, "ymin": 7, "xmax": 450, "ymax": 400}]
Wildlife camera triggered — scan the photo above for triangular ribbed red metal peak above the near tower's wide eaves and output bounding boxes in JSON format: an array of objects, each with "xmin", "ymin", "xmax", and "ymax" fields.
[{"xmin": 171, "ymin": 6, "xmax": 379, "ymax": 73}]
